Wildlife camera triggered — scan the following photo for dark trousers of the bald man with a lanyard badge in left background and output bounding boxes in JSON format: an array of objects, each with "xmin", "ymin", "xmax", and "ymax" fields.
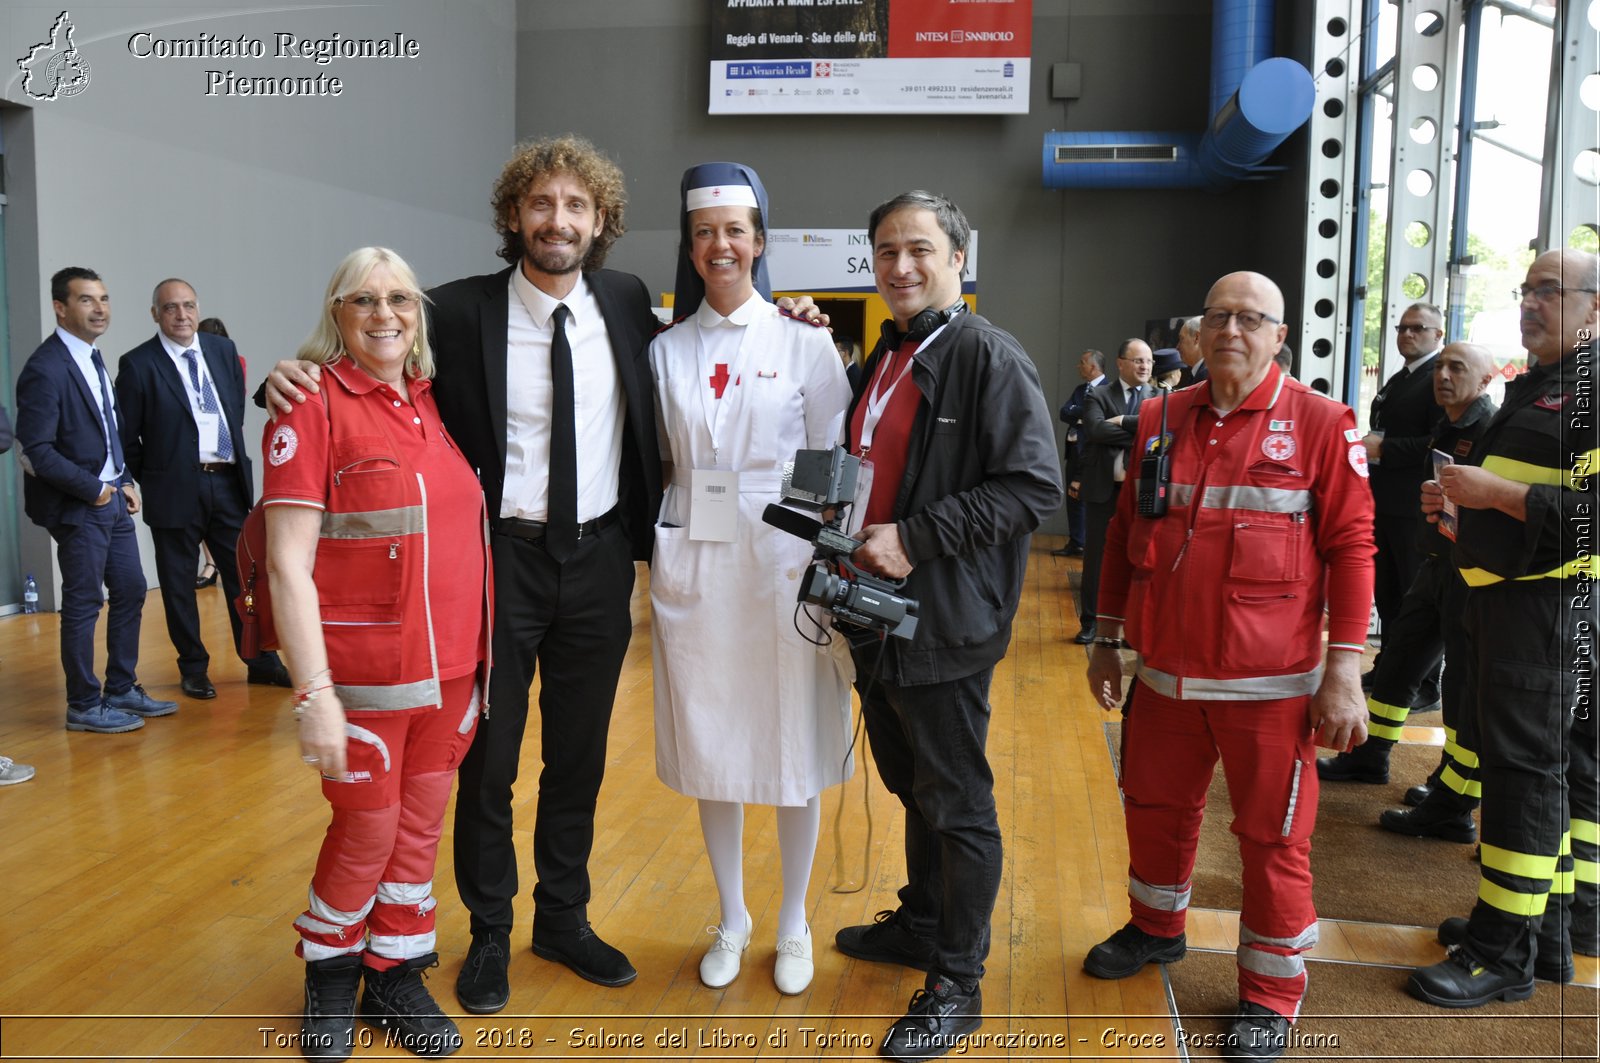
[{"xmin": 150, "ymin": 471, "xmax": 259, "ymax": 676}]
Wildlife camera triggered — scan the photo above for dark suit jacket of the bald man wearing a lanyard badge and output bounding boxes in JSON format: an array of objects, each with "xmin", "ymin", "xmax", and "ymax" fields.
[{"xmin": 117, "ymin": 333, "xmax": 256, "ymax": 528}]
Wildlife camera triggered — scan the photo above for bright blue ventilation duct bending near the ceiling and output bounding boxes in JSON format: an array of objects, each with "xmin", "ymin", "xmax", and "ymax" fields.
[{"xmin": 1043, "ymin": 0, "xmax": 1317, "ymax": 191}]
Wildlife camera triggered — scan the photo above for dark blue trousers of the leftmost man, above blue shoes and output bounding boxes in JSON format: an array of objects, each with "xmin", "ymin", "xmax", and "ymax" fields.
[{"xmin": 50, "ymin": 490, "xmax": 146, "ymax": 712}]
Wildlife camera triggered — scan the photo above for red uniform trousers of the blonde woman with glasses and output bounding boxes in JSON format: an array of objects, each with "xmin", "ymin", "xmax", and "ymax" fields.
[{"xmin": 294, "ymin": 674, "xmax": 478, "ymax": 970}]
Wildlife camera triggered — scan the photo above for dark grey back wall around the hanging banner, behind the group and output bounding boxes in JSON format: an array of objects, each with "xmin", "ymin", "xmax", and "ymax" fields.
[{"xmin": 517, "ymin": 0, "xmax": 1306, "ymax": 532}]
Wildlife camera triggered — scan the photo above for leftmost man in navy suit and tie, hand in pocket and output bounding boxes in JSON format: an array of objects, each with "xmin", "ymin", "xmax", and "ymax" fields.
[{"xmin": 16, "ymin": 266, "xmax": 178, "ymax": 735}]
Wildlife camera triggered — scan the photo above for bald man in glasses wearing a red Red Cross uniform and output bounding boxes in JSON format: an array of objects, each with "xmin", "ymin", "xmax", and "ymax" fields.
[{"xmin": 1083, "ymin": 272, "xmax": 1373, "ymax": 1060}]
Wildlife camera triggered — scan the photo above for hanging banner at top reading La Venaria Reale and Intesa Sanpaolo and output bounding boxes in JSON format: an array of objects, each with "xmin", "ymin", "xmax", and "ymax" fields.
[{"xmin": 710, "ymin": 0, "xmax": 1034, "ymax": 114}]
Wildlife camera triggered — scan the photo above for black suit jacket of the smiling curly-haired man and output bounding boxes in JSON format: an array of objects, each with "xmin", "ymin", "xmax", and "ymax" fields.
[{"xmin": 429, "ymin": 267, "xmax": 661, "ymax": 560}]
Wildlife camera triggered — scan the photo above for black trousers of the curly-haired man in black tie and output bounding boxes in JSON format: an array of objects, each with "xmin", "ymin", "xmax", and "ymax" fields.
[{"xmin": 456, "ymin": 523, "xmax": 634, "ymax": 933}]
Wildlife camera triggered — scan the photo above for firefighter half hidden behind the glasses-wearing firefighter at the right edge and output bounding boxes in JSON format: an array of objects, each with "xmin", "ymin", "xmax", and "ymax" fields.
[{"xmin": 1317, "ymin": 343, "xmax": 1496, "ymax": 842}]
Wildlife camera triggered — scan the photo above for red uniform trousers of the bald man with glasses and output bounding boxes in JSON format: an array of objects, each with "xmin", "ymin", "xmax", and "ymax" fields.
[{"xmin": 1122, "ymin": 682, "xmax": 1317, "ymax": 1021}]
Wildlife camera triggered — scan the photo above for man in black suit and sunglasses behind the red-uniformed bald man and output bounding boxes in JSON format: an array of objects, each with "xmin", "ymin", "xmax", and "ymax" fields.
[{"xmin": 1323, "ymin": 303, "xmax": 1445, "ymax": 723}]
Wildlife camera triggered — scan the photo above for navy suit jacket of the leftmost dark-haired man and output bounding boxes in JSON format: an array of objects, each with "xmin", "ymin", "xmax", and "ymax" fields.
[{"xmin": 16, "ymin": 331, "xmax": 133, "ymax": 528}]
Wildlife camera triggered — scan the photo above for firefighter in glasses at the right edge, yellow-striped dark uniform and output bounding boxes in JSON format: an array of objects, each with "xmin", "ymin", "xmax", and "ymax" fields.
[{"xmin": 1406, "ymin": 250, "xmax": 1600, "ymax": 1007}]
